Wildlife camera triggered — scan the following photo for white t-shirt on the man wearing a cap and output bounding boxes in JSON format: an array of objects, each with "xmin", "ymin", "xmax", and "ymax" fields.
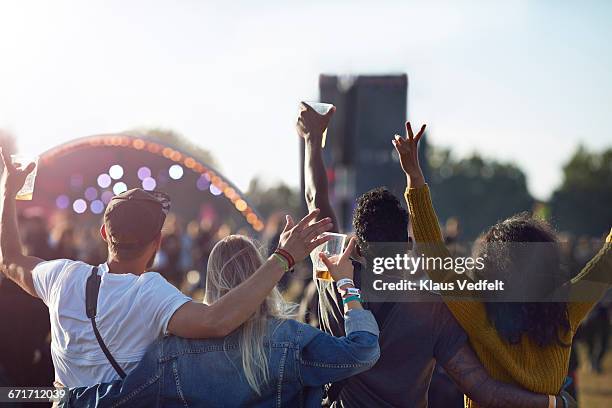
[{"xmin": 32, "ymin": 259, "xmax": 191, "ymax": 387}]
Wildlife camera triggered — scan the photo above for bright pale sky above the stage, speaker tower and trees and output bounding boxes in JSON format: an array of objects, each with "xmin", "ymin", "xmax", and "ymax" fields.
[{"xmin": 0, "ymin": 0, "xmax": 612, "ymax": 198}]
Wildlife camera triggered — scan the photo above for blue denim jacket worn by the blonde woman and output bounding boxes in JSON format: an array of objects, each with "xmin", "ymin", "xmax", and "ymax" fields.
[{"xmin": 63, "ymin": 310, "xmax": 380, "ymax": 407}]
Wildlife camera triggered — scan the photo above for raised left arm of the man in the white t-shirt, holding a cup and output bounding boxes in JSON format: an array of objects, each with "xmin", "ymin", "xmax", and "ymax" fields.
[{"xmin": 0, "ymin": 150, "xmax": 43, "ymax": 297}]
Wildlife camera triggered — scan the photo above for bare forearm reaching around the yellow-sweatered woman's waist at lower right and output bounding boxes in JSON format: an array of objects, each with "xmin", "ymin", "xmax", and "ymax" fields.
[{"xmin": 443, "ymin": 343, "xmax": 563, "ymax": 408}]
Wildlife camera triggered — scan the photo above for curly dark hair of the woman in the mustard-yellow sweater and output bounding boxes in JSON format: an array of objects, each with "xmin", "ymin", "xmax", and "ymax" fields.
[{"xmin": 479, "ymin": 213, "xmax": 570, "ymax": 347}]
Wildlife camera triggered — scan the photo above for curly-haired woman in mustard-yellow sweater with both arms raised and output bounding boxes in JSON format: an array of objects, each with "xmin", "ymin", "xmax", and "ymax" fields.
[{"xmin": 393, "ymin": 122, "xmax": 612, "ymax": 407}]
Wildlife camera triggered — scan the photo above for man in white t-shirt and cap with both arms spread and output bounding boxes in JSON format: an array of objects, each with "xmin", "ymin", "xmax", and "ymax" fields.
[{"xmin": 0, "ymin": 152, "xmax": 331, "ymax": 387}]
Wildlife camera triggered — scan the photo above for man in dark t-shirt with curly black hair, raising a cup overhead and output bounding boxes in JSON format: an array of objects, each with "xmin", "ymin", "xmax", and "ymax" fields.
[{"xmin": 296, "ymin": 104, "xmax": 564, "ymax": 408}]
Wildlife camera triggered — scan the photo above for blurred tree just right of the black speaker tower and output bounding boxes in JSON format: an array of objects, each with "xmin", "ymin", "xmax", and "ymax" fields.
[{"xmin": 428, "ymin": 146, "xmax": 534, "ymax": 239}]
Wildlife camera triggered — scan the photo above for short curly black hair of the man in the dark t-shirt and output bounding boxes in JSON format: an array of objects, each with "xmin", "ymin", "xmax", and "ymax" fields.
[{"xmin": 353, "ymin": 187, "xmax": 408, "ymax": 255}]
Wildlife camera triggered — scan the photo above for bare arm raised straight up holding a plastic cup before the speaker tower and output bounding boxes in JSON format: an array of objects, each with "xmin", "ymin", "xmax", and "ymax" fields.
[{"xmin": 296, "ymin": 103, "xmax": 338, "ymax": 232}]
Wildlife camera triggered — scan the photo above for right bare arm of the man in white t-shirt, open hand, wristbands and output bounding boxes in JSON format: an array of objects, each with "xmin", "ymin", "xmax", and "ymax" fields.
[{"xmin": 168, "ymin": 210, "xmax": 332, "ymax": 338}]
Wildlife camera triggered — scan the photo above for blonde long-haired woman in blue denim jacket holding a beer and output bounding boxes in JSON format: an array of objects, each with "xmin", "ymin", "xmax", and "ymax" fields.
[{"xmin": 67, "ymin": 235, "xmax": 379, "ymax": 407}]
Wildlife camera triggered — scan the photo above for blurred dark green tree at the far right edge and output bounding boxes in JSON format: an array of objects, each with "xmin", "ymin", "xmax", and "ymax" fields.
[{"xmin": 550, "ymin": 146, "xmax": 612, "ymax": 236}]
